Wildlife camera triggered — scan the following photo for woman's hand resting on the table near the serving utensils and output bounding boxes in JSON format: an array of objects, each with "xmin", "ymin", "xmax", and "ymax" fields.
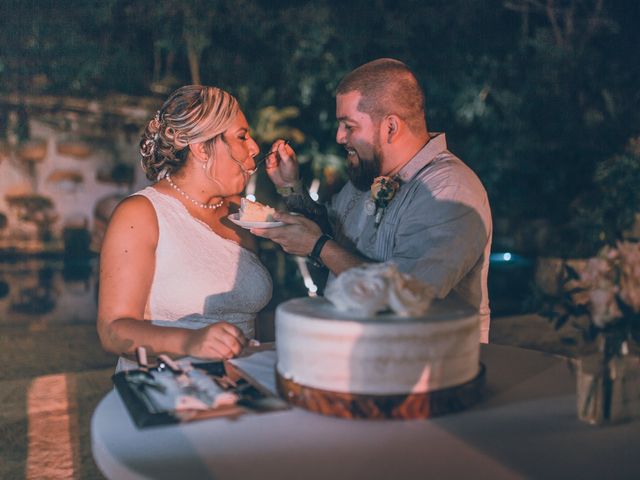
[{"xmin": 185, "ymin": 322, "xmax": 247, "ymax": 359}]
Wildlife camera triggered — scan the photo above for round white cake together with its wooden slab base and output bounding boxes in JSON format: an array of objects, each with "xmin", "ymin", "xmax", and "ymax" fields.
[{"xmin": 276, "ymin": 264, "xmax": 484, "ymax": 418}]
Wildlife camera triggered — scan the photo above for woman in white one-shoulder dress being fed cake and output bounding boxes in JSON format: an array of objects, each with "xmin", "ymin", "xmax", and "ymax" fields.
[{"xmin": 97, "ymin": 85, "xmax": 272, "ymax": 369}]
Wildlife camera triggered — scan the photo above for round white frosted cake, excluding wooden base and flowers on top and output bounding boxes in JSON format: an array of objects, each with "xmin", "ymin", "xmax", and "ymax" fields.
[{"xmin": 276, "ymin": 298, "xmax": 480, "ymax": 395}]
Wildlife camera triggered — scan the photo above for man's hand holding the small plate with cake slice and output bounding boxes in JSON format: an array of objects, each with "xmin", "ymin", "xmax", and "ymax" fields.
[{"xmin": 251, "ymin": 212, "xmax": 322, "ymax": 257}]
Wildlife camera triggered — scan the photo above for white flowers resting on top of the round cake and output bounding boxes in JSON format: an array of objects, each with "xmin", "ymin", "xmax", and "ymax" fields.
[{"xmin": 325, "ymin": 262, "xmax": 435, "ymax": 317}]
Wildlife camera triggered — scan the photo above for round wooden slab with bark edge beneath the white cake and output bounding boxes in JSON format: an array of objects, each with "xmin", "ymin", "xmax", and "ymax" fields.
[{"xmin": 276, "ymin": 364, "xmax": 486, "ymax": 419}]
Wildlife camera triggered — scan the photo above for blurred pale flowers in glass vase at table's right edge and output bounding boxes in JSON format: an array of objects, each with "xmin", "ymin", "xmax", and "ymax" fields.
[{"xmin": 546, "ymin": 241, "xmax": 640, "ymax": 425}]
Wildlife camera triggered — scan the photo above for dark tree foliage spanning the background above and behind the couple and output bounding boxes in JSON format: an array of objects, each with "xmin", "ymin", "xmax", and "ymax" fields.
[{"xmin": 0, "ymin": 0, "xmax": 640, "ymax": 254}]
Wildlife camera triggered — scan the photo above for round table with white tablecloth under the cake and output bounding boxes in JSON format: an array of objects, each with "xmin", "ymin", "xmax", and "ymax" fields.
[{"xmin": 91, "ymin": 345, "xmax": 640, "ymax": 480}]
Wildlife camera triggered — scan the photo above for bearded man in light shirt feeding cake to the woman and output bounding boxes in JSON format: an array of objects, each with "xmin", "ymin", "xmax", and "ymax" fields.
[{"xmin": 252, "ymin": 58, "xmax": 492, "ymax": 342}]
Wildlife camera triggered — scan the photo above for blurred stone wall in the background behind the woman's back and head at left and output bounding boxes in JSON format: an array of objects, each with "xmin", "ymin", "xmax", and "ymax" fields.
[{"xmin": 0, "ymin": 91, "xmax": 160, "ymax": 255}]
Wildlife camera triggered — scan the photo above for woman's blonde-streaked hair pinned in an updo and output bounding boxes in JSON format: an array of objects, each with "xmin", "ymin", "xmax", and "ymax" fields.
[{"xmin": 140, "ymin": 85, "xmax": 240, "ymax": 181}]
